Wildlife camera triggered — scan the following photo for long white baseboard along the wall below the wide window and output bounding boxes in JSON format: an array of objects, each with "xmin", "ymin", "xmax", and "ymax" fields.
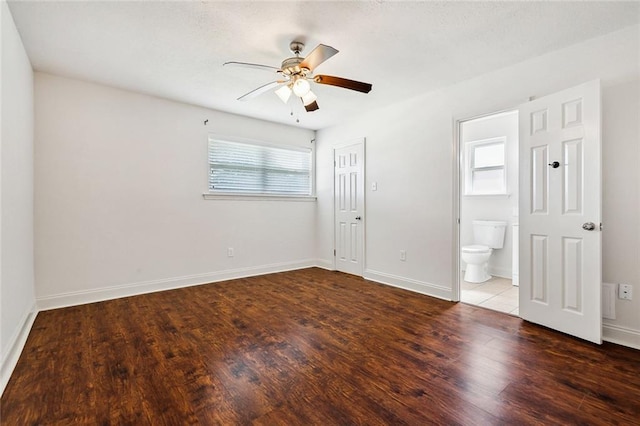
[{"xmin": 36, "ymin": 259, "xmax": 318, "ymax": 311}]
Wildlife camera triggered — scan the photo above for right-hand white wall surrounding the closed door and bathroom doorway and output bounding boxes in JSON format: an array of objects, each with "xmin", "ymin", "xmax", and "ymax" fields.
[{"xmin": 317, "ymin": 26, "xmax": 640, "ymax": 347}]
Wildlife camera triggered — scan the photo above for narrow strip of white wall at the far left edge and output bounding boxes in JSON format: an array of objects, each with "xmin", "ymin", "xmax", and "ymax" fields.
[{"xmin": 0, "ymin": 1, "xmax": 35, "ymax": 393}]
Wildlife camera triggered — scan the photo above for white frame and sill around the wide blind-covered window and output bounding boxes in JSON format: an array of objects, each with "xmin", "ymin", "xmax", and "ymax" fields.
[{"xmin": 202, "ymin": 133, "xmax": 316, "ymax": 201}]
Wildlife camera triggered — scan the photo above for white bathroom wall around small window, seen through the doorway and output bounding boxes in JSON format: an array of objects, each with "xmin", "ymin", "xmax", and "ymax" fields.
[{"xmin": 460, "ymin": 111, "xmax": 518, "ymax": 279}]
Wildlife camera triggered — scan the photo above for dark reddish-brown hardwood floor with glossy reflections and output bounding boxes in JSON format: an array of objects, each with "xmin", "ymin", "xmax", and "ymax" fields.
[{"xmin": 0, "ymin": 269, "xmax": 640, "ymax": 425}]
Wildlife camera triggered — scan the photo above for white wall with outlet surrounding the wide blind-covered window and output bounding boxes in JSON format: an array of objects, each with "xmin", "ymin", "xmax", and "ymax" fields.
[{"xmin": 35, "ymin": 73, "xmax": 315, "ymax": 308}]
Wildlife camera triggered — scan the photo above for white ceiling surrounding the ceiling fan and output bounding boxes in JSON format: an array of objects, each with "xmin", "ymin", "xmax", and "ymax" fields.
[{"xmin": 9, "ymin": 0, "xmax": 640, "ymax": 129}]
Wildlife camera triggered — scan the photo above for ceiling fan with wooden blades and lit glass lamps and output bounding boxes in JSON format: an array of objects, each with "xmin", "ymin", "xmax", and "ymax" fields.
[{"xmin": 223, "ymin": 41, "xmax": 372, "ymax": 112}]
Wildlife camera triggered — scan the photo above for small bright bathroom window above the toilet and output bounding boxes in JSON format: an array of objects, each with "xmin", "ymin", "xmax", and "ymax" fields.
[{"xmin": 465, "ymin": 137, "xmax": 507, "ymax": 195}]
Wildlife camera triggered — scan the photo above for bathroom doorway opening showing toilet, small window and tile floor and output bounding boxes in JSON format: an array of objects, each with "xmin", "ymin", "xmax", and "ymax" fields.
[{"xmin": 458, "ymin": 110, "xmax": 519, "ymax": 316}]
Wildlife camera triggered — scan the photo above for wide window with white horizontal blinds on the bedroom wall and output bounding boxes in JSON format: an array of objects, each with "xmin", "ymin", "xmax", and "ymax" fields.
[{"xmin": 209, "ymin": 136, "xmax": 312, "ymax": 196}]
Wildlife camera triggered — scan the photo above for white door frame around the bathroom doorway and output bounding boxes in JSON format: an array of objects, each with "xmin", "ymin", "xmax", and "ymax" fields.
[{"xmin": 451, "ymin": 105, "xmax": 520, "ymax": 302}]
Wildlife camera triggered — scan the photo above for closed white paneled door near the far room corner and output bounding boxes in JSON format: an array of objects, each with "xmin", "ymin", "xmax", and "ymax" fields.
[{"xmin": 334, "ymin": 142, "xmax": 364, "ymax": 276}]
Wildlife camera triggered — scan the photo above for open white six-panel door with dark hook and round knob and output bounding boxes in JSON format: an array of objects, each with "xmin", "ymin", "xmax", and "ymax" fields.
[{"xmin": 519, "ymin": 80, "xmax": 602, "ymax": 343}]
